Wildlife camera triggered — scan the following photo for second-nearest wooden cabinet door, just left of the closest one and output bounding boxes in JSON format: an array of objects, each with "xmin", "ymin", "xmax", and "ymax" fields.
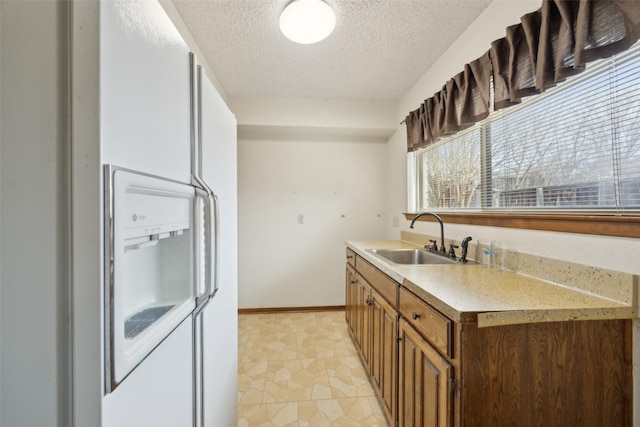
[{"xmin": 371, "ymin": 289, "xmax": 399, "ymax": 420}]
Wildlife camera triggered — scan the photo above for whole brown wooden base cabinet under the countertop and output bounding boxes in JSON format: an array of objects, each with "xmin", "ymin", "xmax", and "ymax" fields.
[{"xmin": 346, "ymin": 249, "xmax": 633, "ymax": 427}]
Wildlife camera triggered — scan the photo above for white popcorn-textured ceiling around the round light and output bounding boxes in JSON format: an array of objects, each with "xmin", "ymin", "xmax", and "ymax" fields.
[{"xmin": 173, "ymin": 0, "xmax": 491, "ymax": 101}]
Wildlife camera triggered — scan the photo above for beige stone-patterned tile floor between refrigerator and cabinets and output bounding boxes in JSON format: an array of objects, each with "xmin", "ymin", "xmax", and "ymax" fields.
[{"xmin": 238, "ymin": 311, "xmax": 388, "ymax": 427}]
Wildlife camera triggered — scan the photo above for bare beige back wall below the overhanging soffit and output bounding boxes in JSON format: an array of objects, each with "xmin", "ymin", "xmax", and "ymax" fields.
[{"xmin": 238, "ymin": 135, "xmax": 388, "ymax": 308}]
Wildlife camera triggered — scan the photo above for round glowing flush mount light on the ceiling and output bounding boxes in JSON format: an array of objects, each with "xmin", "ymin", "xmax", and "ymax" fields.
[{"xmin": 280, "ymin": 0, "xmax": 336, "ymax": 44}]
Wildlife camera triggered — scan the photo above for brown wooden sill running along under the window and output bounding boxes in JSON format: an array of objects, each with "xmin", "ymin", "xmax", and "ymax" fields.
[{"xmin": 404, "ymin": 212, "xmax": 640, "ymax": 238}]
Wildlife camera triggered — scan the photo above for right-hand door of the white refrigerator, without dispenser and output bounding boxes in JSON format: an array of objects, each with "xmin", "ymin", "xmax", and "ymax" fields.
[{"xmin": 200, "ymin": 57, "xmax": 238, "ymax": 427}]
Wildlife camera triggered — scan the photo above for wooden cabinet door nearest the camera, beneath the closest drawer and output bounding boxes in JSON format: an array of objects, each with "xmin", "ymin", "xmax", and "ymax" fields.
[{"xmin": 398, "ymin": 319, "xmax": 453, "ymax": 427}]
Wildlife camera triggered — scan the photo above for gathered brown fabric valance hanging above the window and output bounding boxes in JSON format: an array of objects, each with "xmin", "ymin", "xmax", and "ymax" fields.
[{"xmin": 405, "ymin": 0, "xmax": 640, "ymax": 151}]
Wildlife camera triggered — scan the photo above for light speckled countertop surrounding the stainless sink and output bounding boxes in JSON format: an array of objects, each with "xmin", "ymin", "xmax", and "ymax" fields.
[{"xmin": 346, "ymin": 240, "xmax": 637, "ymax": 327}]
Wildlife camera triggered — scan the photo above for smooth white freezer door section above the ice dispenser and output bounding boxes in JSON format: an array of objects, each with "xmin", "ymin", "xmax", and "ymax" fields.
[{"xmin": 99, "ymin": 0, "xmax": 190, "ymax": 182}]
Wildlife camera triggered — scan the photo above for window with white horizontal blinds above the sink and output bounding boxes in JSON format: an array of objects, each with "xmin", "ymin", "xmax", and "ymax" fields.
[{"xmin": 409, "ymin": 43, "xmax": 640, "ymax": 212}]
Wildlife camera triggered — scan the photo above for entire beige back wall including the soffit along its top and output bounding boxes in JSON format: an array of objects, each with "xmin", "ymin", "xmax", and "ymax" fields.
[{"xmin": 229, "ymin": 98, "xmax": 396, "ymax": 308}]
